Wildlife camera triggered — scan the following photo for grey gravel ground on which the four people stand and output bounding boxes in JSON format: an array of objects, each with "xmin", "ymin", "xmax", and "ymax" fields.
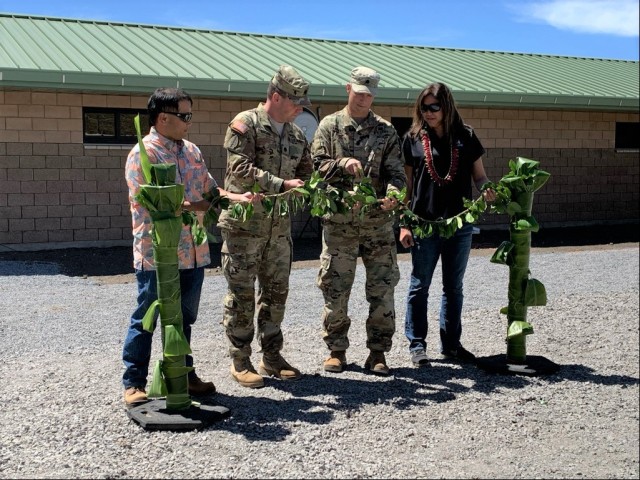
[{"xmin": 0, "ymin": 243, "xmax": 640, "ymax": 479}]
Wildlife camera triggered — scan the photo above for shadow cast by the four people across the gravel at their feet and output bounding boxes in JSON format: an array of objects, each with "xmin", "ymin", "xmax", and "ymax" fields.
[{"xmin": 201, "ymin": 360, "xmax": 639, "ymax": 442}]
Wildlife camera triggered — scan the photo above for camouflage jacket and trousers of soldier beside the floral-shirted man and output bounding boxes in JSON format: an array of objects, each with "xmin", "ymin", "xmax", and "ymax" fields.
[{"xmin": 218, "ymin": 103, "xmax": 313, "ymax": 358}]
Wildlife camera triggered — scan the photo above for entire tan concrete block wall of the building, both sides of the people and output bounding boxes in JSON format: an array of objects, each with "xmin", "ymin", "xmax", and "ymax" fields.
[{"xmin": 0, "ymin": 90, "xmax": 640, "ymax": 249}]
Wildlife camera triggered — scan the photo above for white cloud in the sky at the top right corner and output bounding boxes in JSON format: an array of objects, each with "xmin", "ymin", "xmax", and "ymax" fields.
[{"xmin": 512, "ymin": 0, "xmax": 640, "ymax": 37}]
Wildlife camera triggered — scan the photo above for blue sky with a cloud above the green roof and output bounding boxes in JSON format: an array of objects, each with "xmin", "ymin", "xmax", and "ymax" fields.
[{"xmin": 0, "ymin": 0, "xmax": 640, "ymax": 61}]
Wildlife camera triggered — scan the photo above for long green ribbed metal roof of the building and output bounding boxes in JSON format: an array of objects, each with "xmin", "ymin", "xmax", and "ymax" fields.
[{"xmin": 0, "ymin": 13, "xmax": 640, "ymax": 111}]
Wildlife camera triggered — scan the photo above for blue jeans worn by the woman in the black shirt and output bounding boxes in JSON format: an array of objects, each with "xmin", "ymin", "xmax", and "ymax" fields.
[{"xmin": 404, "ymin": 224, "xmax": 473, "ymax": 352}]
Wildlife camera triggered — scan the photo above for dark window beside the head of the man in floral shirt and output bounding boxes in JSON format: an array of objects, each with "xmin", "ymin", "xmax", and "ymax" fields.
[{"xmin": 82, "ymin": 107, "xmax": 149, "ymax": 144}]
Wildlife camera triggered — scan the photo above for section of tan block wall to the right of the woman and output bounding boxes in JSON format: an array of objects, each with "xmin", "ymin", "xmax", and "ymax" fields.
[{"xmin": 461, "ymin": 108, "xmax": 640, "ymax": 228}]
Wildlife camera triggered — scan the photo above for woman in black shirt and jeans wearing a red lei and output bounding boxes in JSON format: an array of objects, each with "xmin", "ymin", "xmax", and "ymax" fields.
[{"xmin": 400, "ymin": 83, "xmax": 495, "ymax": 366}]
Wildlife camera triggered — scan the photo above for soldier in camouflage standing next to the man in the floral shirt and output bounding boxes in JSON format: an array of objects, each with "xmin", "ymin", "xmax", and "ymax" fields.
[{"xmin": 218, "ymin": 65, "xmax": 313, "ymax": 388}]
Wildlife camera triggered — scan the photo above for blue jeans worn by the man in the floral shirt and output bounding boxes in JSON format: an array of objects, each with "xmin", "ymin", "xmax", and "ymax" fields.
[{"xmin": 122, "ymin": 267, "xmax": 204, "ymax": 388}]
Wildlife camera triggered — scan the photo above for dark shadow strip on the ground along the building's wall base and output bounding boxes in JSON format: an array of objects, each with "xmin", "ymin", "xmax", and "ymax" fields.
[{"xmin": 0, "ymin": 223, "xmax": 639, "ymax": 277}]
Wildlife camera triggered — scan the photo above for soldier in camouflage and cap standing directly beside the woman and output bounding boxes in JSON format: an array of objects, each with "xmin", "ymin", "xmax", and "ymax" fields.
[{"xmin": 311, "ymin": 67, "xmax": 406, "ymax": 375}]
